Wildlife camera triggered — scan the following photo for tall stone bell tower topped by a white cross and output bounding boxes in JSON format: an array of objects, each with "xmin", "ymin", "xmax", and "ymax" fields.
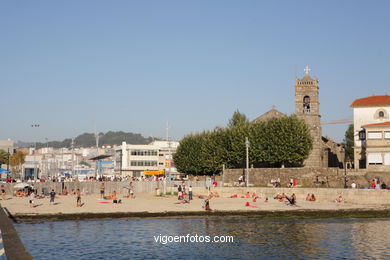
[{"xmin": 295, "ymin": 66, "xmax": 322, "ymax": 167}]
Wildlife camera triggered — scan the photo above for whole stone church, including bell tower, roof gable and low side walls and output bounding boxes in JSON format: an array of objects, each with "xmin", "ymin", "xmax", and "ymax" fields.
[{"xmin": 253, "ymin": 67, "xmax": 344, "ymax": 168}]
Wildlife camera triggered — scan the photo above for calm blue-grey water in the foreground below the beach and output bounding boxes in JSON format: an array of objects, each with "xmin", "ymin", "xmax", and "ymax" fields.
[{"xmin": 16, "ymin": 218, "xmax": 390, "ymax": 260}]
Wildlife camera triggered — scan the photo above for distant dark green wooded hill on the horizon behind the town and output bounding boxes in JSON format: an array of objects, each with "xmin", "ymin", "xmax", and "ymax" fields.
[{"xmin": 25, "ymin": 131, "xmax": 158, "ymax": 148}]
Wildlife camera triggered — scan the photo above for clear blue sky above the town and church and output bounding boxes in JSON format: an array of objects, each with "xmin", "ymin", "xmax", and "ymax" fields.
[{"xmin": 0, "ymin": 0, "xmax": 390, "ymax": 142}]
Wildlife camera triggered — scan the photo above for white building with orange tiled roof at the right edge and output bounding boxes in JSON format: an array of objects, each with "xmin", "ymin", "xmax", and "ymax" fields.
[{"xmin": 351, "ymin": 95, "xmax": 390, "ymax": 171}]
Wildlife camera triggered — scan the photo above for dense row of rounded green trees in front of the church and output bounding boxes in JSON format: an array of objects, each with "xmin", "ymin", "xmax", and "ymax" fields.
[{"xmin": 174, "ymin": 111, "xmax": 313, "ymax": 175}]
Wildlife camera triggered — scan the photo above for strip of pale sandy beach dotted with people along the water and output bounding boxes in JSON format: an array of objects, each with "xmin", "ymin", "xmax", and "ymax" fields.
[{"xmin": 1, "ymin": 194, "xmax": 390, "ymax": 220}]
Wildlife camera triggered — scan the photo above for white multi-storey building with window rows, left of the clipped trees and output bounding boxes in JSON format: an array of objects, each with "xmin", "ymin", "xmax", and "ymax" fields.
[{"xmin": 115, "ymin": 141, "xmax": 179, "ymax": 177}]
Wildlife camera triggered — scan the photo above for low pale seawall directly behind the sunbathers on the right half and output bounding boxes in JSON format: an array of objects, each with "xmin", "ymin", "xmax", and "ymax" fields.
[{"xmin": 194, "ymin": 187, "xmax": 390, "ymax": 205}]
